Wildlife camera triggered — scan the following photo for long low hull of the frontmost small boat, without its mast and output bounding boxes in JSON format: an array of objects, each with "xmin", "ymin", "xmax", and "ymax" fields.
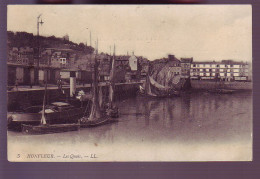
[{"xmin": 22, "ymin": 123, "xmax": 80, "ymax": 134}]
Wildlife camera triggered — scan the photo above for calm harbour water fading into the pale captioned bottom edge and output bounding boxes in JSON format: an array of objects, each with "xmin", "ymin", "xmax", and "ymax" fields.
[{"xmin": 8, "ymin": 92, "xmax": 252, "ymax": 162}]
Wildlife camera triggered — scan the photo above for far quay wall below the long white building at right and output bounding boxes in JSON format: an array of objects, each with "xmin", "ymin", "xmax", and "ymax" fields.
[{"xmin": 190, "ymin": 80, "xmax": 253, "ymax": 90}]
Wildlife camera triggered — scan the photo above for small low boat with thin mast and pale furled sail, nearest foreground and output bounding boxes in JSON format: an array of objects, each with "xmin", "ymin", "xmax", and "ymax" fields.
[{"xmin": 22, "ymin": 82, "xmax": 79, "ymax": 134}]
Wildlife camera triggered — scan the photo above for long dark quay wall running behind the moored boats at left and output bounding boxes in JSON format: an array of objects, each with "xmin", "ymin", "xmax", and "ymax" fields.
[{"xmin": 7, "ymin": 83, "xmax": 139, "ymax": 111}]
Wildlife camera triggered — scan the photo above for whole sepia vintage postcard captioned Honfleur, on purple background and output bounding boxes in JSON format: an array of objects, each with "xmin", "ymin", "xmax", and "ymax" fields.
[{"xmin": 6, "ymin": 5, "xmax": 253, "ymax": 162}]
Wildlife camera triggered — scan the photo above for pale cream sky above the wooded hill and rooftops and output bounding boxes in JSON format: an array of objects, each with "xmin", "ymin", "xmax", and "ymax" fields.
[{"xmin": 7, "ymin": 5, "xmax": 252, "ymax": 62}]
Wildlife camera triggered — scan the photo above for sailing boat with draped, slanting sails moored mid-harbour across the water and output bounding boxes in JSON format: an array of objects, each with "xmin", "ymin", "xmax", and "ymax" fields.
[{"xmin": 140, "ymin": 66, "xmax": 180, "ymax": 97}]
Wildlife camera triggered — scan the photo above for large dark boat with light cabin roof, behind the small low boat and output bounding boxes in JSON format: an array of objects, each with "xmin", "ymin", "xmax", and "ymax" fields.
[{"xmin": 7, "ymin": 102, "xmax": 89, "ymax": 131}]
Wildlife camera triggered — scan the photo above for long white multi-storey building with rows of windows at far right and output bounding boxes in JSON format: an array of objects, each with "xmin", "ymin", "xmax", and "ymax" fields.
[{"xmin": 190, "ymin": 60, "xmax": 249, "ymax": 81}]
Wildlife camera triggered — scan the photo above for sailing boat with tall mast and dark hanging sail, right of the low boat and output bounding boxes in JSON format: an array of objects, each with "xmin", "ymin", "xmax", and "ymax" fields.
[{"xmin": 80, "ymin": 42, "xmax": 117, "ymax": 127}]
